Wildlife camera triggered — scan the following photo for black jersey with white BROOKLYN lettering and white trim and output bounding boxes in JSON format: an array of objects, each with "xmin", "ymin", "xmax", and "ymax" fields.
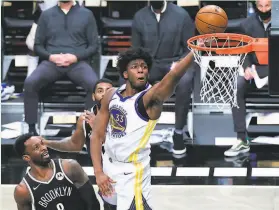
[{"xmin": 23, "ymin": 159, "xmax": 86, "ymax": 210}]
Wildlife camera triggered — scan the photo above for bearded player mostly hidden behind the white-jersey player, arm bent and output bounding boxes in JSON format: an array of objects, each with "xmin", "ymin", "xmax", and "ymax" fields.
[{"xmin": 43, "ymin": 79, "xmax": 112, "ymax": 155}]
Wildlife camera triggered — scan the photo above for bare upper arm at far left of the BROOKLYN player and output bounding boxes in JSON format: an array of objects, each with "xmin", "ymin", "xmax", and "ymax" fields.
[{"xmin": 14, "ymin": 182, "xmax": 32, "ymax": 210}]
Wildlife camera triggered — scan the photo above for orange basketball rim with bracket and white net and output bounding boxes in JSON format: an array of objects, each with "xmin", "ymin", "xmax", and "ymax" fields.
[{"xmin": 187, "ymin": 33, "xmax": 268, "ymax": 109}]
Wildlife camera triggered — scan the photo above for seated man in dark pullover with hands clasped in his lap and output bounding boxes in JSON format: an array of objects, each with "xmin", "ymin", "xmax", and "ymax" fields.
[{"xmin": 24, "ymin": 1, "xmax": 99, "ymax": 135}]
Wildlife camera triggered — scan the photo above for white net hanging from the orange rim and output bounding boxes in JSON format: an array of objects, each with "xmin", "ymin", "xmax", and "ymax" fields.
[{"xmin": 191, "ymin": 37, "xmax": 252, "ymax": 109}]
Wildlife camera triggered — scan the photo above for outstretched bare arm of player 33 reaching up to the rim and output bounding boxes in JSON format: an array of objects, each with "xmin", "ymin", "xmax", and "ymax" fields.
[{"xmin": 143, "ymin": 52, "xmax": 194, "ymax": 120}]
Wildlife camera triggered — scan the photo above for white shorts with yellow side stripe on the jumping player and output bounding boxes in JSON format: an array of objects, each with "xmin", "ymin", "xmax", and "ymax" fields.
[{"xmin": 103, "ymin": 153, "xmax": 152, "ymax": 210}]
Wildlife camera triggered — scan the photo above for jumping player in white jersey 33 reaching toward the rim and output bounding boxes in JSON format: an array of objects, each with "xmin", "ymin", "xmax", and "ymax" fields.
[{"xmin": 90, "ymin": 48, "xmax": 193, "ymax": 210}]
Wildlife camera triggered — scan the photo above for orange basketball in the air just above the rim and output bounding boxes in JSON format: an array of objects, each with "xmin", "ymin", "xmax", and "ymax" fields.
[{"xmin": 195, "ymin": 5, "xmax": 228, "ymax": 34}]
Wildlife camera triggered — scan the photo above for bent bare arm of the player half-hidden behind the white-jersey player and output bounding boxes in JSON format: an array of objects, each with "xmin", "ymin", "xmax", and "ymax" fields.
[{"xmin": 43, "ymin": 114, "xmax": 85, "ymax": 152}]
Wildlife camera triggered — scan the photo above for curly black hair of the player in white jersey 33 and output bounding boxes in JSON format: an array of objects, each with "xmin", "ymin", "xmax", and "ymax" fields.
[{"xmin": 117, "ymin": 47, "xmax": 153, "ymax": 77}]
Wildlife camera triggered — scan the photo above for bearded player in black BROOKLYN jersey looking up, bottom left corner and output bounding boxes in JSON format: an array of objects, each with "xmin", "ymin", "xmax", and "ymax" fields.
[{"xmin": 14, "ymin": 134, "xmax": 100, "ymax": 210}]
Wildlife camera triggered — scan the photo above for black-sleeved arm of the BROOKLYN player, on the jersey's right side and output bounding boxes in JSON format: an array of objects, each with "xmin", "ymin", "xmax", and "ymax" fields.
[{"xmin": 62, "ymin": 160, "xmax": 100, "ymax": 210}]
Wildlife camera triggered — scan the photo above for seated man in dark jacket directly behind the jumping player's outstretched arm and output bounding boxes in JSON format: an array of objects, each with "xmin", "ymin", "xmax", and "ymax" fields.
[{"xmin": 132, "ymin": 0, "xmax": 195, "ymax": 155}]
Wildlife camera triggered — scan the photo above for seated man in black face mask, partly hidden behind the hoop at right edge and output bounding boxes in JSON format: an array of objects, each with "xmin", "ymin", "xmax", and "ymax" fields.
[{"xmin": 225, "ymin": 0, "xmax": 271, "ymax": 156}]
